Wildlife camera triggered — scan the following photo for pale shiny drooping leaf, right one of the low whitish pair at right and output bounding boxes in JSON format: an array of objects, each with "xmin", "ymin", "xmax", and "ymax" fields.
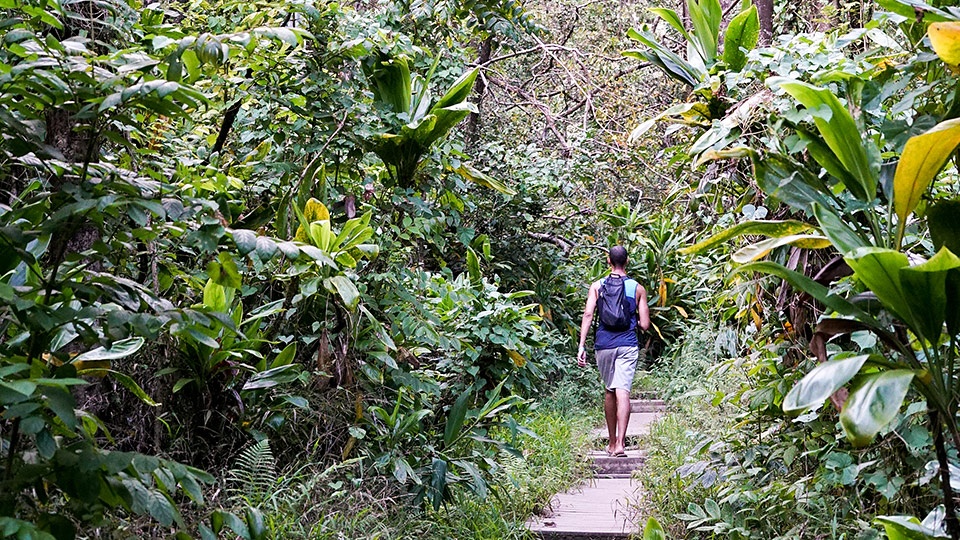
[{"xmin": 840, "ymin": 369, "xmax": 914, "ymax": 447}]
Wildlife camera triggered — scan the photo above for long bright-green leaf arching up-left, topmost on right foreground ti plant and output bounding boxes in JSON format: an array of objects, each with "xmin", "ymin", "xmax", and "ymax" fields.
[{"xmin": 768, "ymin": 77, "xmax": 877, "ymax": 201}]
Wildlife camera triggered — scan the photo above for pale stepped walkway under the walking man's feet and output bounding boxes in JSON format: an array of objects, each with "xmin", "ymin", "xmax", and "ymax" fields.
[{"xmin": 527, "ymin": 399, "xmax": 664, "ymax": 540}]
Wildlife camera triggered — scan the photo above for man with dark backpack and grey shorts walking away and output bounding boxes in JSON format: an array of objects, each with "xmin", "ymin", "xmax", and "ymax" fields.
[{"xmin": 577, "ymin": 246, "xmax": 650, "ymax": 457}]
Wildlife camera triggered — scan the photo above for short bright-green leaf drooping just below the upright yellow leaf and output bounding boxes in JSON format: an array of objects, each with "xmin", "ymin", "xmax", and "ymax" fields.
[{"xmin": 844, "ymin": 246, "xmax": 916, "ymax": 328}]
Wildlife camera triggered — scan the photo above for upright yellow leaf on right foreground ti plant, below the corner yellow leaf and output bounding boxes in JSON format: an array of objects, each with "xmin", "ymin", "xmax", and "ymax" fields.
[{"xmin": 893, "ymin": 118, "xmax": 960, "ymax": 223}]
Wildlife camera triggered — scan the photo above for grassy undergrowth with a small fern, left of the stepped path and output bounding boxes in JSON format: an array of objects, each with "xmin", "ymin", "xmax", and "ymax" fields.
[{"xmin": 198, "ymin": 371, "xmax": 598, "ymax": 540}]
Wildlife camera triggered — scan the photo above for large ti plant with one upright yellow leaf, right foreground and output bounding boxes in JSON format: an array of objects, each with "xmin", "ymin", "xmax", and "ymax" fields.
[{"xmin": 685, "ymin": 6, "xmax": 960, "ymax": 539}]
